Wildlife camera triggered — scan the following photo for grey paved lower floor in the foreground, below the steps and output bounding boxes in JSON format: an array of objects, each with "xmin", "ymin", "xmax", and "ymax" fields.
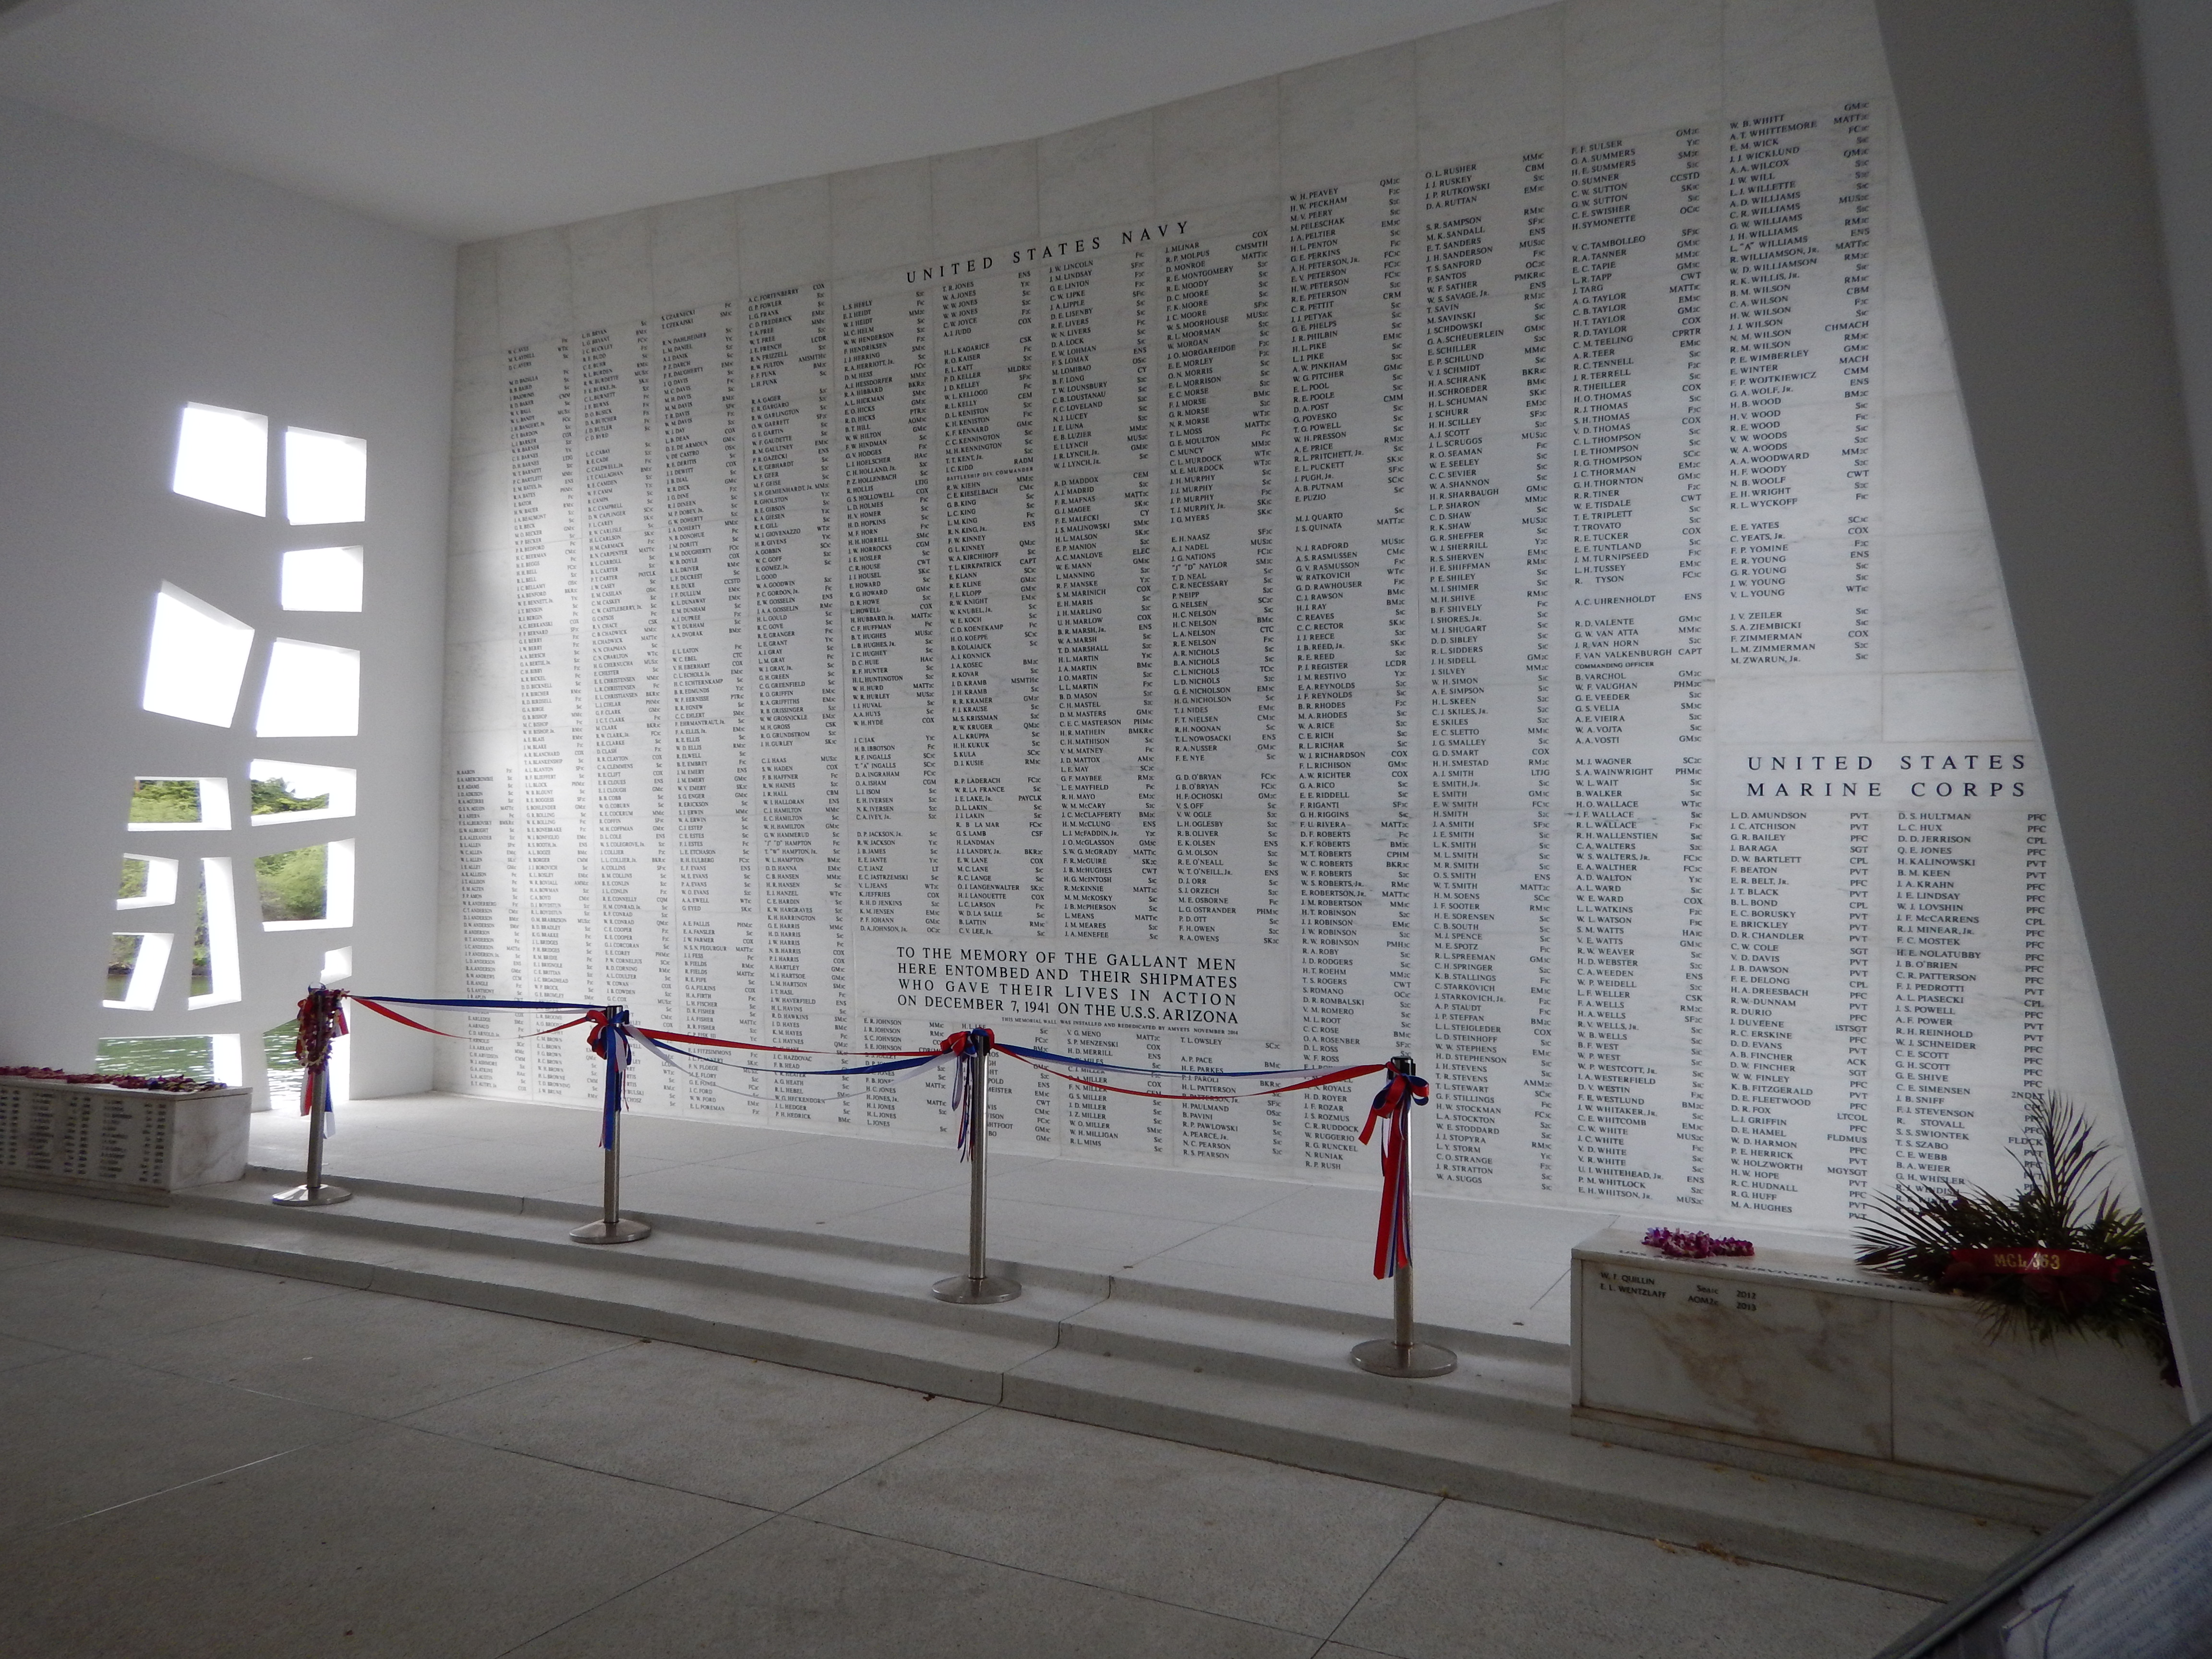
[{"xmin": 0, "ymin": 1238, "xmax": 1927, "ymax": 1659}]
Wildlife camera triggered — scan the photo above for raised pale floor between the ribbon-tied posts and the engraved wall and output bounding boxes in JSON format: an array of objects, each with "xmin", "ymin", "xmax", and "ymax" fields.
[{"xmin": 252, "ymin": 1095, "xmax": 1849, "ymax": 1343}]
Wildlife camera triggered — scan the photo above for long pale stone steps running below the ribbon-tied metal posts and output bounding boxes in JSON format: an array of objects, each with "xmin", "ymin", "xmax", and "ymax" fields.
[{"xmin": 0, "ymin": 1172, "xmax": 2031, "ymax": 1597}]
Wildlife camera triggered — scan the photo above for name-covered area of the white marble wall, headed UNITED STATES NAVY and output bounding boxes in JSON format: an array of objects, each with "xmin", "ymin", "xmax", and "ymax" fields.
[{"xmin": 447, "ymin": 9, "xmax": 2113, "ymax": 1230}]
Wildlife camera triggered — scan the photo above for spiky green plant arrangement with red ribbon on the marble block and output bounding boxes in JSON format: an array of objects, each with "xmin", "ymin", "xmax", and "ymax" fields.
[{"xmin": 1858, "ymin": 1093, "xmax": 2179, "ymax": 1385}]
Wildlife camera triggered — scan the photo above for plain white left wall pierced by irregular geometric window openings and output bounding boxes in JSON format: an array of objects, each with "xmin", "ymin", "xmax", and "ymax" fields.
[{"xmin": 0, "ymin": 90, "xmax": 454, "ymax": 1095}]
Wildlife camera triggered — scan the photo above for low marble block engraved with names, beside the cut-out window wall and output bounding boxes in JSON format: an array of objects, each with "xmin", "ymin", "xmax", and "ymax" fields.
[{"xmin": 0, "ymin": 1077, "xmax": 252, "ymax": 1203}]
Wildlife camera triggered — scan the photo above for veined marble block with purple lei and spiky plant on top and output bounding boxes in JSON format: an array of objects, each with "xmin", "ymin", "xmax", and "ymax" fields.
[{"xmin": 1573, "ymin": 1230, "xmax": 2188, "ymax": 1527}]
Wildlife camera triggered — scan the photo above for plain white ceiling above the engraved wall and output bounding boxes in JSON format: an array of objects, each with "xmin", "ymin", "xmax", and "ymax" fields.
[{"xmin": 0, "ymin": 0, "xmax": 1533, "ymax": 241}]
